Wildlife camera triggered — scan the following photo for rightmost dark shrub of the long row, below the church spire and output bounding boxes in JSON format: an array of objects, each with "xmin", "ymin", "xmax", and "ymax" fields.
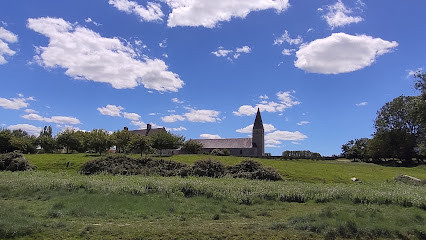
[{"xmin": 226, "ymin": 160, "xmax": 283, "ymax": 181}]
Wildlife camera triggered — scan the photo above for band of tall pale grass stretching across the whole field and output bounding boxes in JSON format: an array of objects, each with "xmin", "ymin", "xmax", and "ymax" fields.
[{"xmin": 0, "ymin": 172, "xmax": 426, "ymax": 209}]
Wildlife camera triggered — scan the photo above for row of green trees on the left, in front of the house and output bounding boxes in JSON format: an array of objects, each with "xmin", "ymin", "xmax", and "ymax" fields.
[{"xmin": 0, "ymin": 126, "xmax": 202, "ymax": 156}]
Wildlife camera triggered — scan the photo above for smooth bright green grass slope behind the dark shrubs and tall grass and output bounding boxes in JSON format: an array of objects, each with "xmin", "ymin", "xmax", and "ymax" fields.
[{"xmin": 25, "ymin": 154, "xmax": 426, "ymax": 183}]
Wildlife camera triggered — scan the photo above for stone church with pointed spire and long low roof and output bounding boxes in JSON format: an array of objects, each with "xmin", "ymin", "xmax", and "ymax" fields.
[{"xmin": 193, "ymin": 109, "xmax": 265, "ymax": 157}]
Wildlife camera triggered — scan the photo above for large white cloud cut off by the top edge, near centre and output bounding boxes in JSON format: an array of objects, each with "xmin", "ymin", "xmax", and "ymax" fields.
[{"xmin": 164, "ymin": 0, "xmax": 290, "ymax": 28}]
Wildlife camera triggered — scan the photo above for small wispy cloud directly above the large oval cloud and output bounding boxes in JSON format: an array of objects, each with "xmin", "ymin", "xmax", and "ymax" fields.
[{"xmin": 322, "ymin": 0, "xmax": 364, "ymax": 29}]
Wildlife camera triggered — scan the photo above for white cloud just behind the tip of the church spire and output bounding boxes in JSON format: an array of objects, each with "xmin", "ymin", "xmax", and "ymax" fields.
[{"xmin": 232, "ymin": 91, "xmax": 301, "ymax": 116}]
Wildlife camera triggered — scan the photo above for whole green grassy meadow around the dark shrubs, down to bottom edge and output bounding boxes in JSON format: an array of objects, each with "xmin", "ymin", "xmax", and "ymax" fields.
[{"xmin": 0, "ymin": 154, "xmax": 426, "ymax": 239}]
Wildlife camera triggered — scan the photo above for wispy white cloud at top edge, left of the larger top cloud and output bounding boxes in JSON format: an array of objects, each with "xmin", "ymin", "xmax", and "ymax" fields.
[{"xmin": 108, "ymin": 0, "xmax": 164, "ymax": 22}]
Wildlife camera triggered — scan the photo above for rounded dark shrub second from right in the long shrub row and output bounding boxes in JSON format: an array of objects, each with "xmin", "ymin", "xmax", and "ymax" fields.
[{"xmin": 192, "ymin": 159, "xmax": 225, "ymax": 178}]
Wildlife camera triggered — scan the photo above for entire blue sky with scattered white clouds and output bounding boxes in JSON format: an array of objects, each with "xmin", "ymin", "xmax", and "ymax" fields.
[{"xmin": 0, "ymin": 0, "xmax": 426, "ymax": 155}]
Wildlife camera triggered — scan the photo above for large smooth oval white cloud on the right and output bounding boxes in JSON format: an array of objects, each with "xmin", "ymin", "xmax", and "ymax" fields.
[{"xmin": 294, "ymin": 33, "xmax": 398, "ymax": 74}]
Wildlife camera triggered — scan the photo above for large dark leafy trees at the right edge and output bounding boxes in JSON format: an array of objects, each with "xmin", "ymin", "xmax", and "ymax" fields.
[{"xmin": 342, "ymin": 72, "xmax": 426, "ymax": 165}]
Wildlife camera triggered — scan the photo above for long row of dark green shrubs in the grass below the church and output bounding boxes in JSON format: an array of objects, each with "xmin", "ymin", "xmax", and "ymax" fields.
[{"xmin": 81, "ymin": 155, "xmax": 282, "ymax": 181}]
